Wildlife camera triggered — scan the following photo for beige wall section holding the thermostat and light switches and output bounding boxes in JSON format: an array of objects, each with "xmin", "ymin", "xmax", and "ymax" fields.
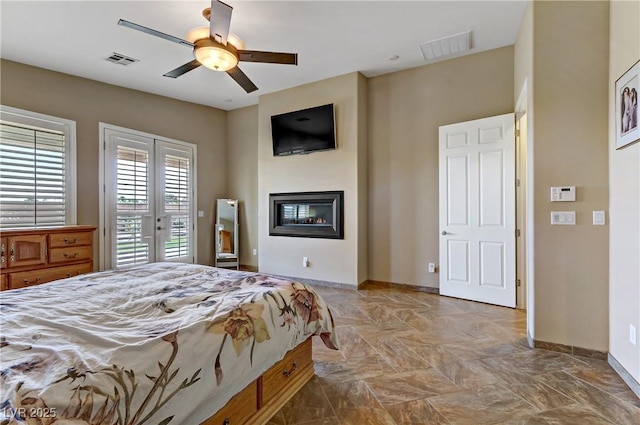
[{"xmin": 532, "ymin": 1, "xmax": 609, "ymax": 351}]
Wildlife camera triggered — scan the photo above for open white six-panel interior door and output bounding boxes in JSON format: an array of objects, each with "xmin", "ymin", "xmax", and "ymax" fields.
[{"xmin": 439, "ymin": 114, "xmax": 516, "ymax": 307}]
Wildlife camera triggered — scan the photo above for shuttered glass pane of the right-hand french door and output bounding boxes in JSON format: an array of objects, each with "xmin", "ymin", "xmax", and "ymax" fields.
[{"xmin": 164, "ymin": 155, "xmax": 191, "ymax": 260}]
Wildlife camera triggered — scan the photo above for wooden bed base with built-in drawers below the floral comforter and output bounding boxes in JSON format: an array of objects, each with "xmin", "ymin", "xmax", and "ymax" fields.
[{"xmin": 201, "ymin": 338, "xmax": 314, "ymax": 425}]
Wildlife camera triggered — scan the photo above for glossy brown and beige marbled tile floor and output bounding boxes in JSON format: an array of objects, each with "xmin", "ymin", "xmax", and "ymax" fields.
[{"xmin": 269, "ymin": 286, "xmax": 640, "ymax": 425}]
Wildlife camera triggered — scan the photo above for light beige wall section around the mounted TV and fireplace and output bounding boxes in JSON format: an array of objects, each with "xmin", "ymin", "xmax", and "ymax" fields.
[{"xmin": 258, "ymin": 73, "xmax": 366, "ymax": 285}]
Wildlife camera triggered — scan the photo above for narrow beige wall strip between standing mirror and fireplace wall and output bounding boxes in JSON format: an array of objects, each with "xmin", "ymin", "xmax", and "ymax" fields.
[{"xmin": 227, "ymin": 105, "xmax": 258, "ymax": 267}]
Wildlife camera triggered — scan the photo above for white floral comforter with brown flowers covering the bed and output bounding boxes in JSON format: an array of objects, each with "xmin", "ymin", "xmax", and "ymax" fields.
[{"xmin": 0, "ymin": 263, "xmax": 338, "ymax": 425}]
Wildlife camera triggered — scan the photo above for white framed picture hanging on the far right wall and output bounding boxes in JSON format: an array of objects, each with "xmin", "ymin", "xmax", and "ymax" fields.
[{"xmin": 615, "ymin": 61, "xmax": 640, "ymax": 149}]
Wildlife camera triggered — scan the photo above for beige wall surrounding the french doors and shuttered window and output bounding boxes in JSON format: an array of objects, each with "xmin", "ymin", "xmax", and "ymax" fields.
[{"xmin": 0, "ymin": 60, "xmax": 227, "ymax": 264}]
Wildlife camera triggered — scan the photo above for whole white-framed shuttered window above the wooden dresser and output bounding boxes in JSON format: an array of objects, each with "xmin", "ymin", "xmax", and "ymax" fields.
[{"xmin": 0, "ymin": 106, "xmax": 76, "ymax": 229}]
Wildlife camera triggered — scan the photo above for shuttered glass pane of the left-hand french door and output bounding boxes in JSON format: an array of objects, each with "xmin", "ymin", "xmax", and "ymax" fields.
[{"xmin": 116, "ymin": 146, "xmax": 153, "ymax": 268}]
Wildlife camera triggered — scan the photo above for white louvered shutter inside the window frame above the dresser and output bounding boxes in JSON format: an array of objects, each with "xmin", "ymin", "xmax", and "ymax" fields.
[{"xmin": 0, "ymin": 122, "xmax": 70, "ymax": 228}]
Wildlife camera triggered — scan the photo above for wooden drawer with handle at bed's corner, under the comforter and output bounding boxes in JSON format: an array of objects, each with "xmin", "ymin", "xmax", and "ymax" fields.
[{"xmin": 262, "ymin": 338, "xmax": 313, "ymax": 403}]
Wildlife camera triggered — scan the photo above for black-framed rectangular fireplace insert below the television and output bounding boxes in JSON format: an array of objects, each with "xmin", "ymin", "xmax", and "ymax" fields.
[{"xmin": 269, "ymin": 190, "xmax": 344, "ymax": 239}]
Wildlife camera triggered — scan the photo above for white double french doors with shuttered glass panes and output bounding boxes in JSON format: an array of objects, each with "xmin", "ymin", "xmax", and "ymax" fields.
[{"xmin": 103, "ymin": 128, "xmax": 195, "ymax": 269}]
